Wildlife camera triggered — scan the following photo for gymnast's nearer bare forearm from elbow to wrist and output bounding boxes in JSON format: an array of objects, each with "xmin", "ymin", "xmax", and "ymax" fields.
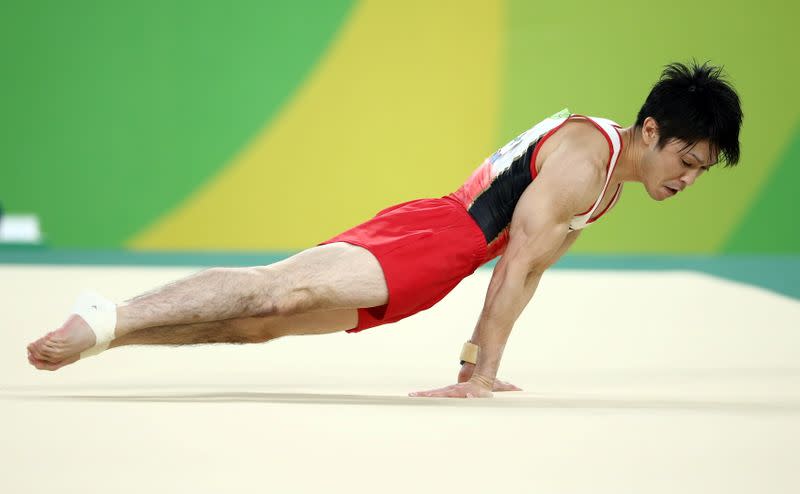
[{"xmin": 470, "ymin": 260, "xmax": 541, "ymax": 387}]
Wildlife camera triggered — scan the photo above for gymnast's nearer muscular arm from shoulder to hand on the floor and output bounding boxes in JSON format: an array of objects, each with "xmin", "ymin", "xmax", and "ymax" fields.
[{"xmin": 410, "ymin": 123, "xmax": 609, "ymax": 398}]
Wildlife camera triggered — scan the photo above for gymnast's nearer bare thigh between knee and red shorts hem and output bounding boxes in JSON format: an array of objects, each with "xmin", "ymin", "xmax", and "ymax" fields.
[{"xmin": 258, "ymin": 242, "xmax": 389, "ymax": 312}]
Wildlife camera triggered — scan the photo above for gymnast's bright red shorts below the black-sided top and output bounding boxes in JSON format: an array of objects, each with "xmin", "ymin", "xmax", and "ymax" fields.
[{"xmin": 323, "ymin": 197, "xmax": 486, "ymax": 333}]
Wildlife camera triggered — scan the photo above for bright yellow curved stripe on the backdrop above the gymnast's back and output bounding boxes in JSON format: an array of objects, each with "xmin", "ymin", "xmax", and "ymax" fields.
[{"xmin": 128, "ymin": 1, "xmax": 503, "ymax": 250}]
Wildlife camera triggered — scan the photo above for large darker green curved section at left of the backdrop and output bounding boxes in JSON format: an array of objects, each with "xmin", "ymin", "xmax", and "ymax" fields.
[{"xmin": 0, "ymin": 0, "xmax": 351, "ymax": 247}]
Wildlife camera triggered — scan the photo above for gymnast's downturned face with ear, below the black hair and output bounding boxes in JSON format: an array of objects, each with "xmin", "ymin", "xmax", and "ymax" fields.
[{"xmin": 642, "ymin": 118, "xmax": 717, "ymax": 201}]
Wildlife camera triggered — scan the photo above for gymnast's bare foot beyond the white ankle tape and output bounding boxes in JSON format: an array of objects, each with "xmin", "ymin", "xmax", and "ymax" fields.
[{"xmin": 28, "ymin": 314, "xmax": 95, "ymax": 370}]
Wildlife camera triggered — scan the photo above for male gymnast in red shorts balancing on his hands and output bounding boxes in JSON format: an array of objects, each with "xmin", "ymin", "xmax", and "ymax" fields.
[{"xmin": 28, "ymin": 63, "xmax": 742, "ymax": 398}]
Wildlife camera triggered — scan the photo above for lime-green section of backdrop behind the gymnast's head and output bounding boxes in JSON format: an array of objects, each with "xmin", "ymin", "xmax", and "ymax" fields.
[{"xmin": 501, "ymin": 0, "xmax": 800, "ymax": 253}]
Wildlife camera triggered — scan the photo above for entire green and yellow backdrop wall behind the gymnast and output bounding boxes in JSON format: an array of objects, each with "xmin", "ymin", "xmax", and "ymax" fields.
[{"xmin": 0, "ymin": 0, "xmax": 800, "ymax": 254}]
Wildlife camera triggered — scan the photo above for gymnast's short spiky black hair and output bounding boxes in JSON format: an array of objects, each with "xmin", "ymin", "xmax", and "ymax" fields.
[{"xmin": 636, "ymin": 61, "xmax": 742, "ymax": 166}]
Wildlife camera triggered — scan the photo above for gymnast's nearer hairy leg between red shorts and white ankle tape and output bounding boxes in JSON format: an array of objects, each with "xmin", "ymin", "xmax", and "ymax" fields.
[{"xmin": 116, "ymin": 243, "xmax": 388, "ymax": 337}]
